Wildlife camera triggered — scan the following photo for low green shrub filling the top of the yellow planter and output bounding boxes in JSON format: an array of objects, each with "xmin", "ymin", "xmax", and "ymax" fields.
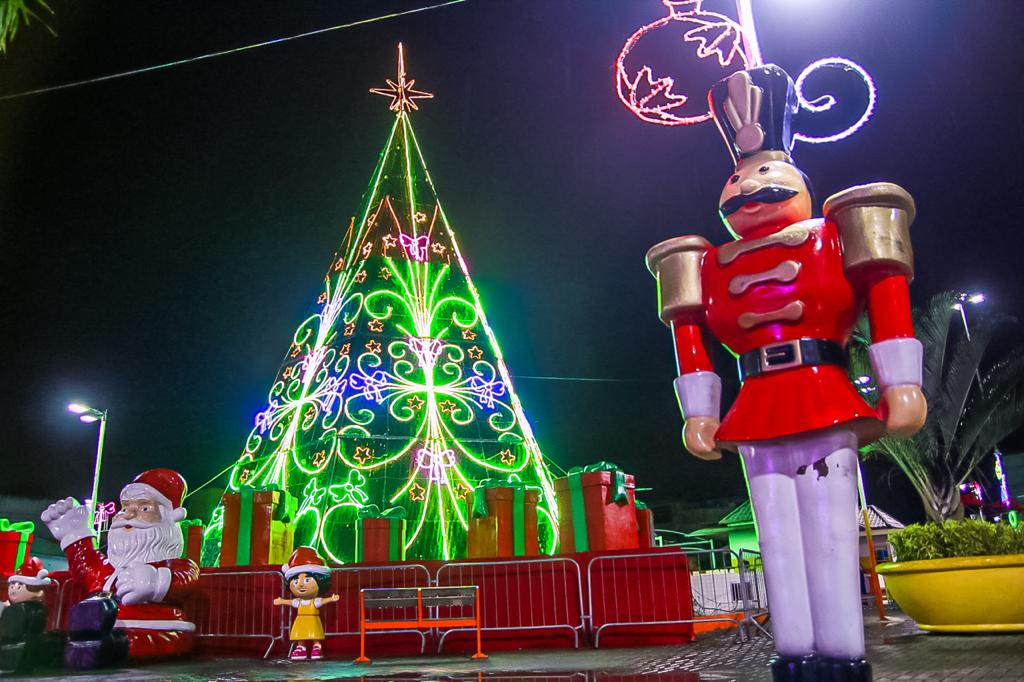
[{"xmin": 889, "ymin": 519, "xmax": 1024, "ymax": 561}]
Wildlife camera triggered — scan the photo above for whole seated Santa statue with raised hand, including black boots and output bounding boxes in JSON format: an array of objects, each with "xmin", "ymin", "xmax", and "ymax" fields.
[{"xmin": 42, "ymin": 469, "xmax": 199, "ymax": 668}]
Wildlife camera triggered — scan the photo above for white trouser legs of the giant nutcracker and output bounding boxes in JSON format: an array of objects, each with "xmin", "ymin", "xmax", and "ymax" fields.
[{"xmin": 739, "ymin": 428, "xmax": 864, "ymax": 657}]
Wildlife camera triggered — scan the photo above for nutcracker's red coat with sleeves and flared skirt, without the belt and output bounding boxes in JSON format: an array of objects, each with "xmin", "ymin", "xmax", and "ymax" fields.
[{"xmin": 674, "ymin": 218, "xmax": 913, "ymax": 446}]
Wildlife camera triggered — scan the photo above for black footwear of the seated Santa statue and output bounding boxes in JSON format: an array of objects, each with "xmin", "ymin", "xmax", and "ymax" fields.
[{"xmin": 65, "ymin": 597, "xmax": 128, "ymax": 670}]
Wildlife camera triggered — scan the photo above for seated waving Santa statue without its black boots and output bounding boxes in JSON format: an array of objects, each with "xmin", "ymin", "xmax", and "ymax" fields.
[{"xmin": 43, "ymin": 469, "xmax": 199, "ymax": 660}]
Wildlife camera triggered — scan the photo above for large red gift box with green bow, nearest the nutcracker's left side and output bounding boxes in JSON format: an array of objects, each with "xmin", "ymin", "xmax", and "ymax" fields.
[{"xmin": 555, "ymin": 462, "xmax": 640, "ymax": 553}]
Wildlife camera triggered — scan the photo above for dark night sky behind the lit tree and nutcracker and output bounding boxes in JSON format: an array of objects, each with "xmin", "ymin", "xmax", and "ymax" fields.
[{"xmin": 0, "ymin": 0, "xmax": 1024, "ymax": 520}]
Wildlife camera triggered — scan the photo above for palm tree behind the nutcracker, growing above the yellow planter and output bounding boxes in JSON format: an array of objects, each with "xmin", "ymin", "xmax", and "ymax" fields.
[{"xmin": 850, "ymin": 293, "xmax": 1024, "ymax": 523}]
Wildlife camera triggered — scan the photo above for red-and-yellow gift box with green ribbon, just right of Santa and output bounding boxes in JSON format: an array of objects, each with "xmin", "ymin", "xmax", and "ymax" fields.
[{"xmin": 220, "ymin": 487, "xmax": 296, "ymax": 566}]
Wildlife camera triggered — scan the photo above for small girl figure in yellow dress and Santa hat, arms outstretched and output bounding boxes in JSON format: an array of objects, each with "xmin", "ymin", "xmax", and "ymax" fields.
[{"xmin": 273, "ymin": 547, "xmax": 341, "ymax": 660}]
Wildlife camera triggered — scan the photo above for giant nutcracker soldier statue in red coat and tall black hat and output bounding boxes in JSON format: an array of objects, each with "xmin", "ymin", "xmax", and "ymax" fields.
[{"xmin": 647, "ymin": 66, "xmax": 927, "ymax": 680}]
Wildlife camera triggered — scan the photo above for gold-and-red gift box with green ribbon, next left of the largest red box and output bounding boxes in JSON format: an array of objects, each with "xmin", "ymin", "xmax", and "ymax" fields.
[{"xmin": 466, "ymin": 479, "xmax": 540, "ymax": 559}]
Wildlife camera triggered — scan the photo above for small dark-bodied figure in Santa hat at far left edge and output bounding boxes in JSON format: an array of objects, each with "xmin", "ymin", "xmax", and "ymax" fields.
[{"xmin": 0, "ymin": 557, "xmax": 61, "ymax": 674}]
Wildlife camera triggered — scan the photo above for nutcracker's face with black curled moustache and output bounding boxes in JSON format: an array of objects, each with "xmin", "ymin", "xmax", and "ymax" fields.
[{"xmin": 719, "ymin": 152, "xmax": 812, "ymax": 239}]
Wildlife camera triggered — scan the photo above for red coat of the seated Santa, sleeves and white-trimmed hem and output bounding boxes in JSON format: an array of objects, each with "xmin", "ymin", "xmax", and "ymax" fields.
[{"xmin": 65, "ymin": 538, "xmax": 199, "ymax": 630}]
